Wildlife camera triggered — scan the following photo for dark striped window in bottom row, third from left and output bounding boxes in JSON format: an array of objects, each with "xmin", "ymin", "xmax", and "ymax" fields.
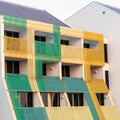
[{"xmin": 68, "ymin": 93, "xmax": 84, "ymax": 106}]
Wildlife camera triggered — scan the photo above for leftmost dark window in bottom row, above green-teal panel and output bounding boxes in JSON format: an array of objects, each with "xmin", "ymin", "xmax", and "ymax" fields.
[{"xmin": 19, "ymin": 92, "xmax": 33, "ymax": 107}]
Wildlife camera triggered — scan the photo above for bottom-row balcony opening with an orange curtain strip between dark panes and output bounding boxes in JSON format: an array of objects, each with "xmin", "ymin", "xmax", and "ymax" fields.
[{"xmin": 41, "ymin": 92, "xmax": 60, "ymax": 107}]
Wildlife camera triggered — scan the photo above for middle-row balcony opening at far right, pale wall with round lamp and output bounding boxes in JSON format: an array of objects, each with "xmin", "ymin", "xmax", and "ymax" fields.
[{"xmin": 90, "ymin": 66, "xmax": 103, "ymax": 79}]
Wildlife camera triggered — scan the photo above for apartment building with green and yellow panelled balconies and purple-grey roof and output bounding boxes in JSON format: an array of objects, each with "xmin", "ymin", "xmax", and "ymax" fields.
[{"xmin": 0, "ymin": 2, "xmax": 120, "ymax": 120}]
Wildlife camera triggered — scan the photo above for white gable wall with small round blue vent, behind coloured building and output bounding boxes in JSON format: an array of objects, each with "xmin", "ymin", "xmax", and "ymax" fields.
[{"xmin": 65, "ymin": 2, "xmax": 120, "ymax": 112}]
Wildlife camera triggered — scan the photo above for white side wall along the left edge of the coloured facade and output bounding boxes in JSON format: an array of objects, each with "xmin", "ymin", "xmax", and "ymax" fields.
[{"xmin": 0, "ymin": 16, "xmax": 15, "ymax": 120}]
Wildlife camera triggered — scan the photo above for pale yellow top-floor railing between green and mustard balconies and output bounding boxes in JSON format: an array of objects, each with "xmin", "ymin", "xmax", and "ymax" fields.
[{"xmin": 61, "ymin": 45, "xmax": 83, "ymax": 64}]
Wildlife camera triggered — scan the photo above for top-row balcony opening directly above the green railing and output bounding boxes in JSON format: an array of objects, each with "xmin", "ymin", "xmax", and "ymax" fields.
[{"xmin": 34, "ymin": 31, "xmax": 54, "ymax": 43}]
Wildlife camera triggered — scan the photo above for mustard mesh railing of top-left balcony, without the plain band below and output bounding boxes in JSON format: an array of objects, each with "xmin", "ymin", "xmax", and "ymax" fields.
[{"xmin": 4, "ymin": 36, "xmax": 28, "ymax": 53}]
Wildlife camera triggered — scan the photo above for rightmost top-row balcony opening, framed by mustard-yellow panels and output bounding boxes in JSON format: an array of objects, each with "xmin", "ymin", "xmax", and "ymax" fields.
[{"xmin": 83, "ymin": 40, "xmax": 98, "ymax": 50}]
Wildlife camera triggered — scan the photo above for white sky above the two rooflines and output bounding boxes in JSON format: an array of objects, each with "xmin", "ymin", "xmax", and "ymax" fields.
[{"xmin": 0, "ymin": 0, "xmax": 120, "ymax": 21}]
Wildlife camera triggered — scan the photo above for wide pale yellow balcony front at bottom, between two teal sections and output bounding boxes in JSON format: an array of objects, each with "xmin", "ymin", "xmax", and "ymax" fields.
[{"xmin": 46, "ymin": 106, "xmax": 93, "ymax": 120}]
